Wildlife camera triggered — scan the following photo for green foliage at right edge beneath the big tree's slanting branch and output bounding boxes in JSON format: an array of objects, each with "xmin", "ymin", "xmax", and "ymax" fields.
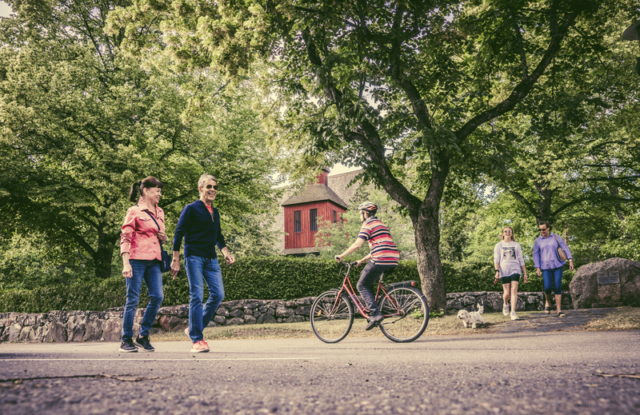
[{"xmin": 476, "ymin": 10, "xmax": 640, "ymax": 233}]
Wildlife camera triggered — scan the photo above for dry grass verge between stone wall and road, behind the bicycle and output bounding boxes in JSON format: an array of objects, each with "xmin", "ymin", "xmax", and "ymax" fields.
[{"xmin": 153, "ymin": 311, "xmax": 535, "ymax": 342}]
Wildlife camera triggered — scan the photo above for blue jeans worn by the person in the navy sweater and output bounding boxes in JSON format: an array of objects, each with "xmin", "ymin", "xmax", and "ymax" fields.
[{"xmin": 184, "ymin": 256, "xmax": 224, "ymax": 343}]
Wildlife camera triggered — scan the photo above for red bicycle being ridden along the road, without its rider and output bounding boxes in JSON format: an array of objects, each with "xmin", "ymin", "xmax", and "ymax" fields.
[{"xmin": 310, "ymin": 262, "xmax": 429, "ymax": 343}]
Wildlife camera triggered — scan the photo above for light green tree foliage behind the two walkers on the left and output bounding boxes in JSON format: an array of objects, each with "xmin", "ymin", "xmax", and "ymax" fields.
[{"xmin": 0, "ymin": 0, "xmax": 277, "ymax": 281}]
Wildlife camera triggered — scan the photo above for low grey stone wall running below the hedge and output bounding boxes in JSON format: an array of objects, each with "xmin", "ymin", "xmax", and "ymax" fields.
[{"xmin": 0, "ymin": 291, "xmax": 571, "ymax": 343}]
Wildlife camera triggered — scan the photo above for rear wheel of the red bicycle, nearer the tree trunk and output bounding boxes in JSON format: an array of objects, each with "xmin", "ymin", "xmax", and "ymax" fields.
[{"xmin": 380, "ymin": 287, "xmax": 429, "ymax": 343}]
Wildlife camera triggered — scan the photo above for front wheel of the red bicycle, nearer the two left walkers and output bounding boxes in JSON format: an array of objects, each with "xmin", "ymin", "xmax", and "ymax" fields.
[{"xmin": 310, "ymin": 291, "xmax": 353, "ymax": 343}]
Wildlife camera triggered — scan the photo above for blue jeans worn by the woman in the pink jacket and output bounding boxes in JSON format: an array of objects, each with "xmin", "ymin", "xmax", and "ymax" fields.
[{"xmin": 122, "ymin": 259, "xmax": 164, "ymax": 341}]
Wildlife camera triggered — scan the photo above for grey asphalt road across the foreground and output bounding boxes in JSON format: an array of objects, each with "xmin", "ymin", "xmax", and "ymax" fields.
[{"xmin": 0, "ymin": 331, "xmax": 640, "ymax": 415}]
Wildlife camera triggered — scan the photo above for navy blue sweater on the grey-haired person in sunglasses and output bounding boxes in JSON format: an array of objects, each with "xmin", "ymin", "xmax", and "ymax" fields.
[{"xmin": 173, "ymin": 200, "xmax": 227, "ymax": 259}]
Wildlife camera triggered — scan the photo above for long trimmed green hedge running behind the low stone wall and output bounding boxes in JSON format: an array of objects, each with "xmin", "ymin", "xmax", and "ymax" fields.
[{"xmin": 0, "ymin": 257, "xmax": 570, "ymax": 313}]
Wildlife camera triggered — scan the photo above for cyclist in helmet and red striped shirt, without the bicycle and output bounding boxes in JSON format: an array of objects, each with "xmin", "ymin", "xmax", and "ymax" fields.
[{"xmin": 335, "ymin": 202, "xmax": 400, "ymax": 330}]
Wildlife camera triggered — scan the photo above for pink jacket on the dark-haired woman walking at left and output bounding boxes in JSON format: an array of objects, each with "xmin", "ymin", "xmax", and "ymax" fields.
[{"xmin": 120, "ymin": 205, "xmax": 164, "ymax": 261}]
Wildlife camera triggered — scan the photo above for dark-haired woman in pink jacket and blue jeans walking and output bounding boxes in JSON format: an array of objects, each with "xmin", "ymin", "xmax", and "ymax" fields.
[{"xmin": 120, "ymin": 176, "xmax": 167, "ymax": 353}]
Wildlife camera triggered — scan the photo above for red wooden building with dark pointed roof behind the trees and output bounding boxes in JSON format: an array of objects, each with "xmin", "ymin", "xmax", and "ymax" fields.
[{"xmin": 282, "ymin": 169, "xmax": 347, "ymax": 256}]
